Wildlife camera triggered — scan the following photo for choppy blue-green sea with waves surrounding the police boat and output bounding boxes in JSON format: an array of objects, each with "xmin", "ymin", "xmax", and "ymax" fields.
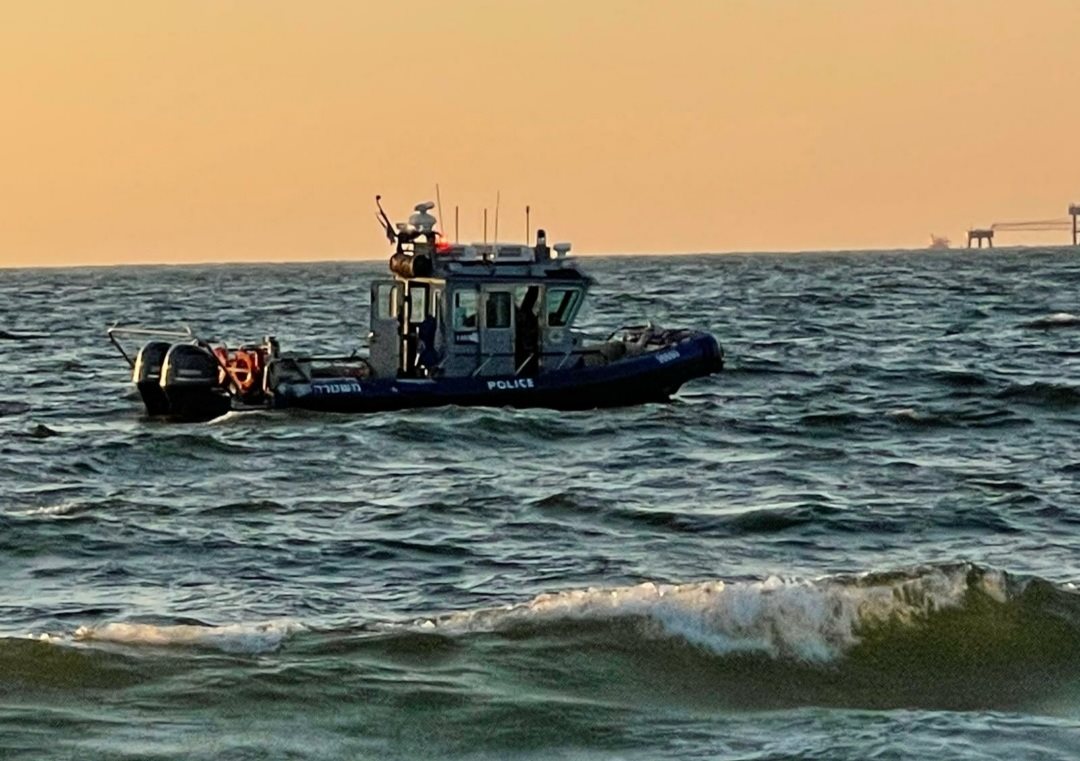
[{"xmin": 0, "ymin": 248, "xmax": 1080, "ymax": 761}]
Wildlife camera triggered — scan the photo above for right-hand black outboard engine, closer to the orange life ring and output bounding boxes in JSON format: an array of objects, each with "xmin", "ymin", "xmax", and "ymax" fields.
[{"xmin": 161, "ymin": 343, "xmax": 232, "ymax": 421}]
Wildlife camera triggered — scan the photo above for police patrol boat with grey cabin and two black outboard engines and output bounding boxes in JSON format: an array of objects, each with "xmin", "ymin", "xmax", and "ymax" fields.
[{"xmin": 108, "ymin": 196, "xmax": 724, "ymax": 421}]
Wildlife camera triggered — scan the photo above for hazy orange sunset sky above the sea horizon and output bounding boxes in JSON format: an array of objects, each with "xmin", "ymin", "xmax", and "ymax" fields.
[{"xmin": 0, "ymin": 0, "xmax": 1080, "ymax": 266}]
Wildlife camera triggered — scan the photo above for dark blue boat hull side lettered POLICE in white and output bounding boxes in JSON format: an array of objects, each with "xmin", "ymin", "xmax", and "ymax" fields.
[{"xmin": 273, "ymin": 334, "xmax": 724, "ymax": 412}]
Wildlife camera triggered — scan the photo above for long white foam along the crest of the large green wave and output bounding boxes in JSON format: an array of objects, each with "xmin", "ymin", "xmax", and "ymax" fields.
[{"xmin": 417, "ymin": 567, "xmax": 1007, "ymax": 662}]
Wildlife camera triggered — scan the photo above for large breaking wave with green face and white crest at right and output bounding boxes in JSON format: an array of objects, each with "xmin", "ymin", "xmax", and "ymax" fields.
[{"xmin": 386, "ymin": 565, "xmax": 1080, "ymax": 714}]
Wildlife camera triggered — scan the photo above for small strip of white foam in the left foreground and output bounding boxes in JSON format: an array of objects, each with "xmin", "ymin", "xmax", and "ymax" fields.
[{"xmin": 75, "ymin": 621, "xmax": 306, "ymax": 653}]
